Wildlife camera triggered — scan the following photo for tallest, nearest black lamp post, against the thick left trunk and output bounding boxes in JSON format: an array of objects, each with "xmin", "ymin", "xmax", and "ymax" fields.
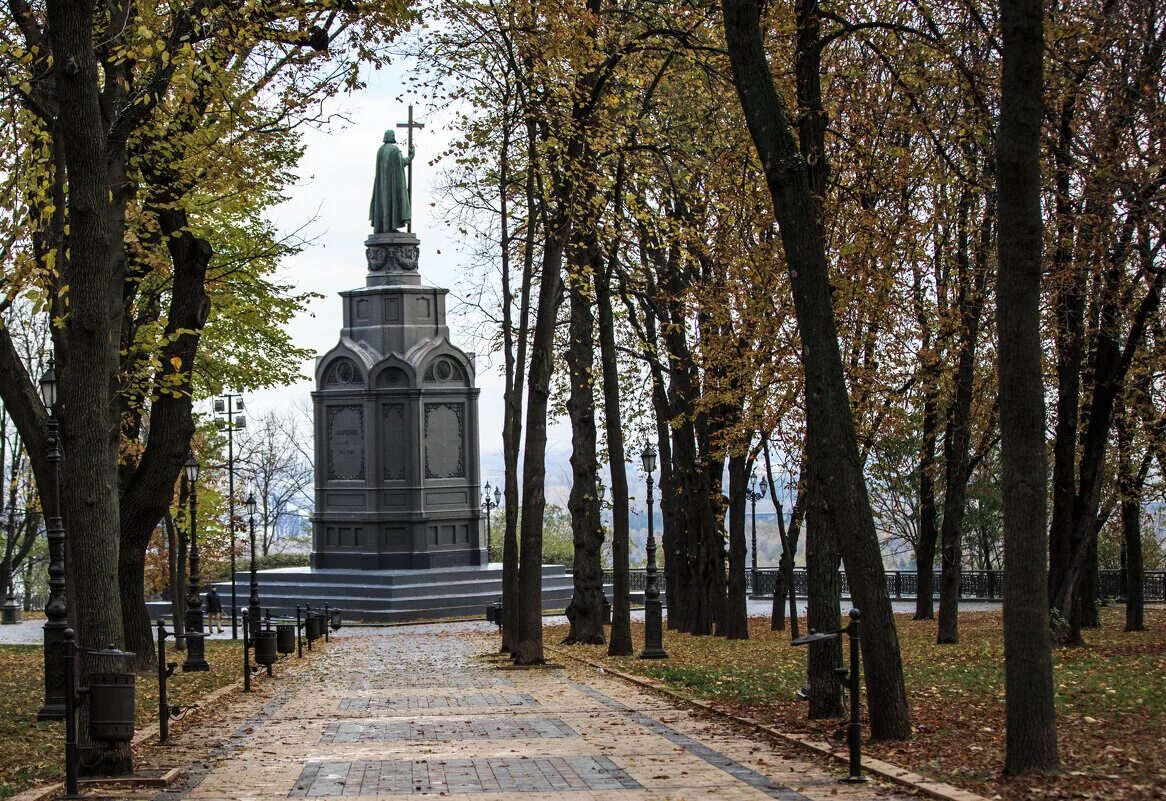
[{"xmin": 36, "ymin": 357, "xmax": 69, "ymax": 721}]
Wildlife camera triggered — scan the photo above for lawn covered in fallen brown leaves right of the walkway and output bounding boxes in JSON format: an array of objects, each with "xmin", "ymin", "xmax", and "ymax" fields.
[{"xmin": 546, "ymin": 606, "xmax": 1166, "ymax": 801}]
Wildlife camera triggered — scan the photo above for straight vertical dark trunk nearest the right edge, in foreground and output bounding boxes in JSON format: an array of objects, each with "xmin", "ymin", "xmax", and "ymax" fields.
[{"xmin": 996, "ymin": 0, "xmax": 1059, "ymax": 774}]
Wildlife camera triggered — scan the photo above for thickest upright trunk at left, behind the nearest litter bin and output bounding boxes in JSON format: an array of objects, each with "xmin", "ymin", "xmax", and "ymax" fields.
[{"xmin": 48, "ymin": 0, "xmax": 133, "ymax": 774}]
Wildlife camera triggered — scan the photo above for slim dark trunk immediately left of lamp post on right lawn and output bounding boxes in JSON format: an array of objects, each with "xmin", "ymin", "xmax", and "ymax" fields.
[{"xmin": 595, "ymin": 266, "xmax": 633, "ymax": 656}]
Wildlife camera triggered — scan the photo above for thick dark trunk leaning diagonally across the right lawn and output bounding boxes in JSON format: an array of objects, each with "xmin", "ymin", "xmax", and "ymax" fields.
[{"xmin": 723, "ymin": 0, "xmax": 911, "ymax": 739}]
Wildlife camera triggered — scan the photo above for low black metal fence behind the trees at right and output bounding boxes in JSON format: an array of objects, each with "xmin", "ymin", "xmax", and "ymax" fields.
[{"xmin": 603, "ymin": 568, "xmax": 1166, "ymax": 602}]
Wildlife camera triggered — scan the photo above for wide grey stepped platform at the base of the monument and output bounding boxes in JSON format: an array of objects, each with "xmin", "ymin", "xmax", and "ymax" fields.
[{"xmin": 206, "ymin": 563, "xmax": 573, "ymax": 623}]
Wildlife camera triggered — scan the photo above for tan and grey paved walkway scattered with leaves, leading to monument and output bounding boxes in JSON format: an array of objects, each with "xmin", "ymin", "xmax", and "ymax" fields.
[{"xmin": 142, "ymin": 624, "xmax": 905, "ymax": 801}]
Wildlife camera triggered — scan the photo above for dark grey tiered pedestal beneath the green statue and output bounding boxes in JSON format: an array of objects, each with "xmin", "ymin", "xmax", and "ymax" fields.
[{"xmin": 311, "ymin": 233, "xmax": 486, "ymax": 570}]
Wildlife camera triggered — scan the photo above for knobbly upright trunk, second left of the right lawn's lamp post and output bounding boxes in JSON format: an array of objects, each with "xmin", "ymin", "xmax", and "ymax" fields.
[{"xmin": 563, "ymin": 282, "xmax": 604, "ymax": 644}]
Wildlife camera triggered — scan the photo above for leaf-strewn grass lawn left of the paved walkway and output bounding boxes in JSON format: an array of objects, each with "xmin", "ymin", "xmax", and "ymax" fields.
[{"xmin": 0, "ymin": 640, "xmax": 243, "ymax": 799}]
